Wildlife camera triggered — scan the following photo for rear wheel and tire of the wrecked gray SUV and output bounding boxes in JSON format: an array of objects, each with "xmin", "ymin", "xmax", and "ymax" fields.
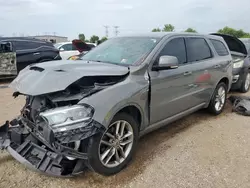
[{"xmin": 208, "ymin": 82, "xmax": 227, "ymax": 115}]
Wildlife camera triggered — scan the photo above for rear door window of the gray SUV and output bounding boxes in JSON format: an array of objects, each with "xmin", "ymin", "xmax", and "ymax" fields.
[{"xmin": 186, "ymin": 38, "xmax": 212, "ymax": 62}]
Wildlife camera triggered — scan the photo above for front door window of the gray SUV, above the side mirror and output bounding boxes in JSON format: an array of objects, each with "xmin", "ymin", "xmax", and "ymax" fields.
[{"xmin": 159, "ymin": 38, "xmax": 187, "ymax": 64}]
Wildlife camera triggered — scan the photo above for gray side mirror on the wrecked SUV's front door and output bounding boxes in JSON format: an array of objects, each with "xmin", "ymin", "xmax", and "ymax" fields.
[{"xmin": 152, "ymin": 55, "xmax": 179, "ymax": 71}]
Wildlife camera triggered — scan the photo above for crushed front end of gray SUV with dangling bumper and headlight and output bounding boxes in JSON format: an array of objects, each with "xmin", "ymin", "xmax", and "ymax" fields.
[{"xmin": 0, "ymin": 93, "xmax": 105, "ymax": 176}]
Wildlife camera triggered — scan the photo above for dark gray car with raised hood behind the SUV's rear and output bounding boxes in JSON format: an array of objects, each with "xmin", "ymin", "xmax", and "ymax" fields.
[{"xmin": 213, "ymin": 33, "xmax": 250, "ymax": 93}]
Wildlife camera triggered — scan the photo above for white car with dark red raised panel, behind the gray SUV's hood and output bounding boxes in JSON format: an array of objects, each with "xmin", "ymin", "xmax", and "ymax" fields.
[{"xmin": 54, "ymin": 40, "xmax": 96, "ymax": 59}]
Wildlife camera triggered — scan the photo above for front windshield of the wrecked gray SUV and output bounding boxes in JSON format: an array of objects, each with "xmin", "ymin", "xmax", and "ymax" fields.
[{"xmin": 81, "ymin": 37, "xmax": 160, "ymax": 66}]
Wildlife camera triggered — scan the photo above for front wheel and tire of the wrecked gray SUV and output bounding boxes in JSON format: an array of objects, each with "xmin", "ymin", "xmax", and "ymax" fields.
[{"xmin": 87, "ymin": 113, "xmax": 139, "ymax": 176}]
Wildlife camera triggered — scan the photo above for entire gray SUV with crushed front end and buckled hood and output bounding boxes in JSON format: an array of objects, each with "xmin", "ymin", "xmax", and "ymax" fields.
[{"xmin": 0, "ymin": 33, "xmax": 232, "ymax": 176}]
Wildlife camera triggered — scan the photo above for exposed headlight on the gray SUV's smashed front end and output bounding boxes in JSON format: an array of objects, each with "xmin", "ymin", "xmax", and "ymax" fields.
[{"xmin": 40, "ymin": 104, "xmax": 94, "ymax": 132}]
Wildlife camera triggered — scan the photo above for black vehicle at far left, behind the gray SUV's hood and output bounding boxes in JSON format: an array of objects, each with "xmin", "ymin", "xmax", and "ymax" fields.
[{"xmin": 0, "ymin": 37, "xmax": 61, "ymax": 78}]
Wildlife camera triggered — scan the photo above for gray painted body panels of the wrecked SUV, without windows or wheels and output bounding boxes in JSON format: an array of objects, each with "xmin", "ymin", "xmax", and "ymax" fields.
[{"xmin": 9, "ymin": 33, "xmax": 232, "ymax": 134}]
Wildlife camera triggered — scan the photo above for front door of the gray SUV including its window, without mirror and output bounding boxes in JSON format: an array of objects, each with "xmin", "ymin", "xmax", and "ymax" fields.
[{"xmin": 149, "ymin": 37, "xmax": 199, "ymax": 124}]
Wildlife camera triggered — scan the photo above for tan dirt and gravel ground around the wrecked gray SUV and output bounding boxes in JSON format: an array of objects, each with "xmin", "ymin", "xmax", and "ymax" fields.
[{"xmin": 0, "ymin": 85, "xmax": 250, "ymax": 188}]
